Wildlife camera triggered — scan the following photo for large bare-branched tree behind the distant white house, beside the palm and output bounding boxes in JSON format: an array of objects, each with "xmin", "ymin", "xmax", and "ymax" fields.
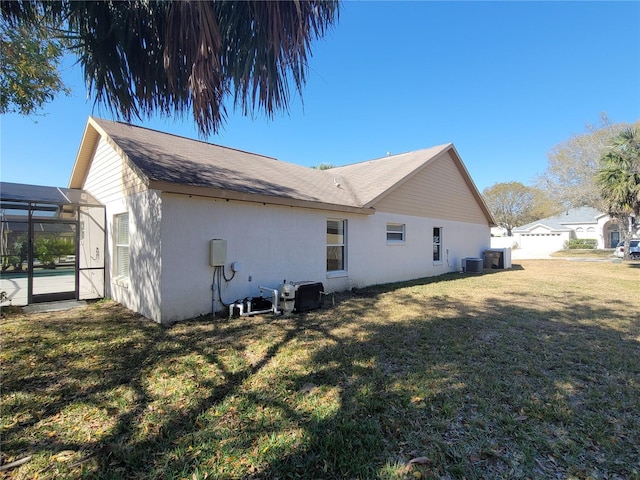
[{"xmin": 536, "ymin": 114, "xmax": 640, "ymax": 212}]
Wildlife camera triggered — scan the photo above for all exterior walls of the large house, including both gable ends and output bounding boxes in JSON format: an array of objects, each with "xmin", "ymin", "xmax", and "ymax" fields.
[{"xmin": 84, "ymin": 135, "xmax": 490, "ymax": 323}]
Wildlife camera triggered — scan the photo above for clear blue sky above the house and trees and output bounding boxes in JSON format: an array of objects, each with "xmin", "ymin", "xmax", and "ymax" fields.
[{"xmin": 0, "ymin": 1, "xmax": 640, "ymax": 191}]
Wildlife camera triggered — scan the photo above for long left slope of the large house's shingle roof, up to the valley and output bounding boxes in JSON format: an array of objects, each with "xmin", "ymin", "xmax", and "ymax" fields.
[{"xmin": 94, "ymin": 119, "xmax": 359, "ymax": 206}]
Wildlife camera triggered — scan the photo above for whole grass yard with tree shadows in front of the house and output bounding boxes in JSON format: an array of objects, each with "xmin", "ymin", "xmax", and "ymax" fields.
[{"xmin": 0, "ymin": 260, "xmax": 640, "ymax": 480}]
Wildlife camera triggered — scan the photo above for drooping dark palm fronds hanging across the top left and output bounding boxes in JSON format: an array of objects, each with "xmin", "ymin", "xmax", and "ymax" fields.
[{"xmin": 0, "ymin": 0, "xmax": 339, "ymax": 136}]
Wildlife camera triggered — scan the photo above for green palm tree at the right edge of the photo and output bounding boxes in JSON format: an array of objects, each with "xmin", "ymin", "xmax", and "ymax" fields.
[{"xmin": 596, "ymin": 127, "xmax": 640, "ymax": 259}]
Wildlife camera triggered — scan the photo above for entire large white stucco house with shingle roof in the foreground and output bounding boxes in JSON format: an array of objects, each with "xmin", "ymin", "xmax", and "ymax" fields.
[{"xmin": 70, "ymin": 118, "xmax": 494, "ymax": 323}]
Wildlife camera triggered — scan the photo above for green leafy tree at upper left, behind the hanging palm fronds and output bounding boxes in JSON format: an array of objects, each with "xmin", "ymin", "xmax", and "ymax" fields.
[{"xmin": 0, "ymin": 13, "xmax": 69, "ymax": 115}]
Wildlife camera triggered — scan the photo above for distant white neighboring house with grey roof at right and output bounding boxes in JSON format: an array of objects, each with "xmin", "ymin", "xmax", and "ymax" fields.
[{"xmin": 512, "ymin": 207, "xmax": 621, "ymax": 252}]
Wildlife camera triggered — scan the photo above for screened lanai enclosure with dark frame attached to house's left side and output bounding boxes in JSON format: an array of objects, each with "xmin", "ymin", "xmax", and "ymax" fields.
[{"xmin": 0, "ymin": 182, "xmax": 105, "ymax": 306}]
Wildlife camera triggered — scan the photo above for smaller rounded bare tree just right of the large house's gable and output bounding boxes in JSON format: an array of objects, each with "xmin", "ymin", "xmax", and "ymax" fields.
[{"xmin": 482, "ymin": 182, "xmax": 556, "ymax": 236}]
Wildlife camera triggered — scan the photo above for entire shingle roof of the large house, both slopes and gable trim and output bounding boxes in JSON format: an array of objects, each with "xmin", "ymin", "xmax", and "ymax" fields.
[{"xmin": 70, "ymin": 117, "xmax": 491, "ymax": 220}]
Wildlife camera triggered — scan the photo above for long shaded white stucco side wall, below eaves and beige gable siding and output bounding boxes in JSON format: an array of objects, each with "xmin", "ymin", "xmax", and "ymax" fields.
[{"xmin": 160, "ymin": 194, "xmax": 490, "ymax": 322}]
